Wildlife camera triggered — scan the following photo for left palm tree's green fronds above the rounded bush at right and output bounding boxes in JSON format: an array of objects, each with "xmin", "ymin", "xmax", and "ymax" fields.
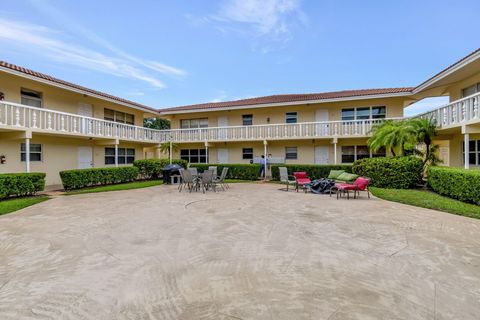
[{"xmin": 368, "ymin": 120, "xmax": 412, "ymax": 156}]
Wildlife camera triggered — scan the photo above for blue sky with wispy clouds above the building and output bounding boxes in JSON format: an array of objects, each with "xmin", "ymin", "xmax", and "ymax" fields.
[{"xmin": 0, "ymin": 0, "xmax": 480, "ymax": 114}]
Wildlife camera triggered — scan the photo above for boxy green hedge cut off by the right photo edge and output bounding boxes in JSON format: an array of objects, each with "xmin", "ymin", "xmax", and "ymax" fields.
[{"xmin": 427, "ymin": 166, "xmax": 480, "ymax": 204}]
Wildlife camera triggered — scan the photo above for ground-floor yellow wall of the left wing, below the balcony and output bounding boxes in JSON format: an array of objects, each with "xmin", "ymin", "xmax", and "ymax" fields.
[{"xmin": 0, "ymin": 132, "xmax": 144, "ymax": 185}]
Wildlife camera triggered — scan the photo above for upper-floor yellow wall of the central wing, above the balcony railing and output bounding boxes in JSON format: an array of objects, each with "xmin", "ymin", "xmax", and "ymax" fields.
[{"xmin": 170, "ymin": 97, "xmax": 405, "ymax": 129}]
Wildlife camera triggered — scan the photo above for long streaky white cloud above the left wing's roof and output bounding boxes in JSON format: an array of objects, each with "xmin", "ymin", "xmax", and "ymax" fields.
[{"xmin": 0, "ymin": 18, "xmax": 184, "ymax": 89}]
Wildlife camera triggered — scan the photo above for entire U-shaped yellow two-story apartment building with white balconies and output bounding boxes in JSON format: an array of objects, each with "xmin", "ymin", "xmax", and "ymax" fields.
[{"xmin": 0, "ymin": 49, "xmax": 480, "ymax": 184}]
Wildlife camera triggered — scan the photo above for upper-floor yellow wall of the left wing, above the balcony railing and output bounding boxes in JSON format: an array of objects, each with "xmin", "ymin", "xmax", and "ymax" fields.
[{"xmin": 0, "ymin": 72, "xmax": 144, "ymax": 127}]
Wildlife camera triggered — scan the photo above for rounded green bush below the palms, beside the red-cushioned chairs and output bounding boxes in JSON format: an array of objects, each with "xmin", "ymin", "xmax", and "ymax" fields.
[{"xmin": 353, "ymin": 156, "xmax": 423, "ymax": 189}]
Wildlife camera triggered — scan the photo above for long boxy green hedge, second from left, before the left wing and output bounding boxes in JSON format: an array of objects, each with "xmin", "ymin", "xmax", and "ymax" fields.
[{"xmin": 60, "ymin": 167, "xmax": 139, "ymax": 190}]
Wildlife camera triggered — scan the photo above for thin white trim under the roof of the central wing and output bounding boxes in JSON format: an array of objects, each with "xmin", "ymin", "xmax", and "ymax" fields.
[{"xmin": 158, "ymin": 91, "xmax": 412, "ymax": 115}]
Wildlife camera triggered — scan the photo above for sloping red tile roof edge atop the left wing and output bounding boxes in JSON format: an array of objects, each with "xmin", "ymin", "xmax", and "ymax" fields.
[{"xmin": 0, "ymin": 61, "xmax": 158, "ymax": 113}]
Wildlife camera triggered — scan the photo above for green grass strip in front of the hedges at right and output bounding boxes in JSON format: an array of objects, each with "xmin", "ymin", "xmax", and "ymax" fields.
[{"xmin": 370, "ymin": 187, "xmax": 480, "ymax": 219}]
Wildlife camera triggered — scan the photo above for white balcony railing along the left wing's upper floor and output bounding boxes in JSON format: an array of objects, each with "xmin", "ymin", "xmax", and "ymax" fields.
[{"xmin": 0, "ymin": 101, "xmax": 169, "ymax": 142}]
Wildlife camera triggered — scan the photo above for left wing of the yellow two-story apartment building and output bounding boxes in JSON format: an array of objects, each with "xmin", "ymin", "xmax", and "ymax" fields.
[{"xmin": 0, "ymin": 62, "xmax": 161, "ymax": 185}]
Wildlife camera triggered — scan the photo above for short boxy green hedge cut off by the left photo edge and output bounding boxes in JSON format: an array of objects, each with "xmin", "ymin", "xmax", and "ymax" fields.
[{"xmin": 0, "ymin": 172, "xmax": 45, "ymax": 199}]
